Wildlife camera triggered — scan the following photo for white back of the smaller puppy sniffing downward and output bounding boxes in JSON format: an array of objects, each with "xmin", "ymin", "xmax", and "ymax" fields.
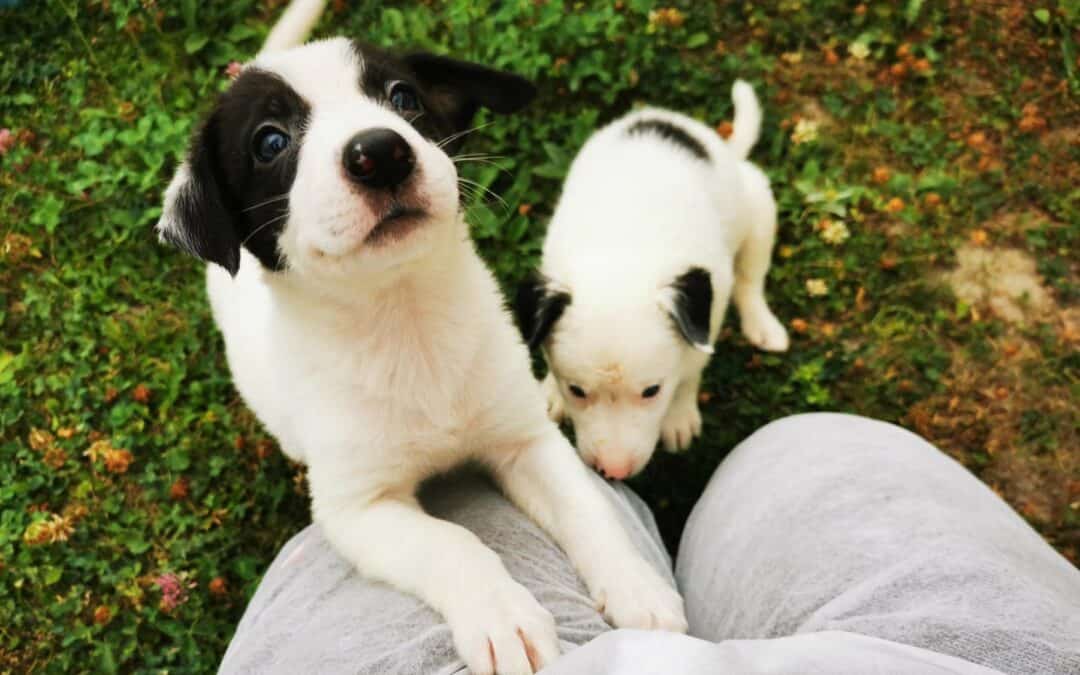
[{"xmin": 543, "ymin": 103, "xmax": 759, "ymax": 304}]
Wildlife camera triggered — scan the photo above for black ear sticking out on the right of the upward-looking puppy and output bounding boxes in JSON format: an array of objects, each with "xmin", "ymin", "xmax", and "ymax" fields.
[{"xmin": 405, "ymin": 52, "xmax": 537, "ymax": 131}]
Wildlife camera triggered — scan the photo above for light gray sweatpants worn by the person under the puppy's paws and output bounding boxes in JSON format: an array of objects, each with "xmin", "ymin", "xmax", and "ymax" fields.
[{"xmin": 221, "ymin": 414, "xmax": 1080, "ymax": 675}]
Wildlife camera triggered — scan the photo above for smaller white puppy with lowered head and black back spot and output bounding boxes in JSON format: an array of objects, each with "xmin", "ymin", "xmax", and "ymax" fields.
[{"xmin": 517, "ymin": 81, "xmax": 787, "ymax": 480}]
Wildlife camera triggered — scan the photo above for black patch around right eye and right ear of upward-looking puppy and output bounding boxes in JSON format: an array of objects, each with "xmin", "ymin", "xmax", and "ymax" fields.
[{"xmin": 353, "ymin": 42, "xmax": 536, "ymax": 153}]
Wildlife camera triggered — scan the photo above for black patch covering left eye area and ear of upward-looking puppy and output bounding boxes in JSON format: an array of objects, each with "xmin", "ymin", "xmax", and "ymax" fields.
[{"xmin": 166, "ymin": 69, "xmax": 311, "ymax": 274}]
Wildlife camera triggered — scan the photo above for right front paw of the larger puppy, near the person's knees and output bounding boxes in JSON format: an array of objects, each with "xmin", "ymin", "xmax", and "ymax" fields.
[{"xmin": 592, "ymin": 561, "xmax": 687, "ymax": 633}]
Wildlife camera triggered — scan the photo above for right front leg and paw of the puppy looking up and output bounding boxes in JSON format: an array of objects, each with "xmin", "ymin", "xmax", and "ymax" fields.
[{"xmin": 494, "ymin": 426, "xmax": 687, "ymax": 633}]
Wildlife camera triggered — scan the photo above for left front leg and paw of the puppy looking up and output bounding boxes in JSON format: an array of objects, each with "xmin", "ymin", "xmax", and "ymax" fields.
[{"xmin": 312, "ymin": 482, "xmax": 558, "ymax": 675}]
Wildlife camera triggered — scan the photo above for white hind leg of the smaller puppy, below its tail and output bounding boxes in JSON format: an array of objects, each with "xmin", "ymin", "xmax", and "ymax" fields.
[{"xmin": 733, "ymin": 163, "xmax": 788, "ymax": 352}]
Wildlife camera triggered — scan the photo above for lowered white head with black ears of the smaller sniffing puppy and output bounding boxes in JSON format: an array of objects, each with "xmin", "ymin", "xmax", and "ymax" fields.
[{"xmin": 515, "ymin": 268, "xmax": 713, "ymax": 480}]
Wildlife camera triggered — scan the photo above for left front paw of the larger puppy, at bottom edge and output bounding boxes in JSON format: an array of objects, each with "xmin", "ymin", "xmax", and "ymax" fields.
[{"xmin": 447, "ymin": 579, "xmax": 559, "ymax": 675}]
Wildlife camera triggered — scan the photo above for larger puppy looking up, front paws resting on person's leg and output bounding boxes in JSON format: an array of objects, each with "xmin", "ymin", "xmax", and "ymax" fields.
[{"xmin": 158, "ymin": 0, "xmax": 686, "ymax": 673}]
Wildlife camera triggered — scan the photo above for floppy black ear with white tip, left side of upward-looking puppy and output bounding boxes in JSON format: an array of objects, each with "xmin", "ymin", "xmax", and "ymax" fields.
[{"xmin": 154, "ymin": 118, "xmax": 240, "ymax": 275}]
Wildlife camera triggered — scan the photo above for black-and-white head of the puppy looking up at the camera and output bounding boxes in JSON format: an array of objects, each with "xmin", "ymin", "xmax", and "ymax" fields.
[{"xmin": 158, "ymin": 38, "xmax": 535, "ymax": 287}]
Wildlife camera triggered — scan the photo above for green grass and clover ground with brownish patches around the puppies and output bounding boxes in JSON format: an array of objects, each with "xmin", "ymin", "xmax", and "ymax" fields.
[{"xmin": 0, "ymin": 0, "xmax": 1080, "ymax": 673}]
